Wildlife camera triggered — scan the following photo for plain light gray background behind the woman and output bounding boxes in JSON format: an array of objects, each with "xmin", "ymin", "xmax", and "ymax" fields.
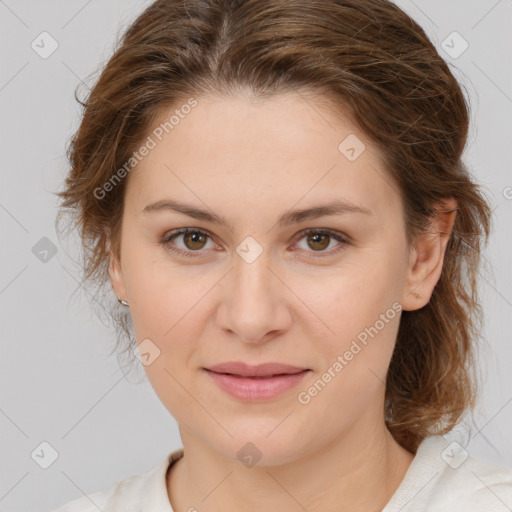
[{"xmin": 0, "ymin": 0, "xmax": 512, "ymax": 512}]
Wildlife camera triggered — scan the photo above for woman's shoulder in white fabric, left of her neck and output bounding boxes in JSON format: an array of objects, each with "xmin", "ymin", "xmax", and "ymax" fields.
[{"xmin": 47, "ymin": 448, "xmax": 183, "ymax": 512}]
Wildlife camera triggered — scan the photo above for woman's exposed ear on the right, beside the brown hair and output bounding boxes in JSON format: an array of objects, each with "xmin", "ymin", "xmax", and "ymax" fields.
[{"xmin": 402, "ymin": 197, "xmax": 457, "ymax": 311}]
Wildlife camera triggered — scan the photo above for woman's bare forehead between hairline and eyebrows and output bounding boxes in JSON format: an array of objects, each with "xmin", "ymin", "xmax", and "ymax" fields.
[{"xmin": 127, "ymin": 93, "xmax": 399, "ymax": 221}]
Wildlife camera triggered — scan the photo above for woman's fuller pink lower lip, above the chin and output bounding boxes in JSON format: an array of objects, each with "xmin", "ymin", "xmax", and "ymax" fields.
[{"xmin": 205, "ymin": 370, "xmax": 310, "ymax": 402}]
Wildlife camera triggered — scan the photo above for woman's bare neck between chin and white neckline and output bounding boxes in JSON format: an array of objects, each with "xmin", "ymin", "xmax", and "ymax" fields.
[{"xmin": 167, "ymin": 414, "xmax": 414, "ymax": 512}]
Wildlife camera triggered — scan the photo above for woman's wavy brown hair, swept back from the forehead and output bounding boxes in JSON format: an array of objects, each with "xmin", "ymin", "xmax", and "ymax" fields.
[{"xmin": 59, "ymin": 0, "xmax": 491, "ymax": 452}]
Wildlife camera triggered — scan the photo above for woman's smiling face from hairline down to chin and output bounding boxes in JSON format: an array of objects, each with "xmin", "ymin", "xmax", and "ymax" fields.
[{"xmin": 111, "ymin": 90, "xmax": 435, "ymax": 465}]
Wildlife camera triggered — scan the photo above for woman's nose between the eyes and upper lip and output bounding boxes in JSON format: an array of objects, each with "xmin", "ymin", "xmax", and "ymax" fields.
[{"xmin": 217, "ymin": 247, "xmax": 293, "ymax": 344}]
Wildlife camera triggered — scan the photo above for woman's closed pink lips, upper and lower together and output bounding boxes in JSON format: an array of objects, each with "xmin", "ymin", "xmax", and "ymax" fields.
[{"xmin": 203, "ymin": 363, "xmax": 311, "ymax": 402}]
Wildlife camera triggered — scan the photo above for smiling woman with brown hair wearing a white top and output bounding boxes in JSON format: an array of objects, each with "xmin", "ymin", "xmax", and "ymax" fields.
[{"xmin": 53, "ymin": 0, "xmax": 512, "ymax": 512}]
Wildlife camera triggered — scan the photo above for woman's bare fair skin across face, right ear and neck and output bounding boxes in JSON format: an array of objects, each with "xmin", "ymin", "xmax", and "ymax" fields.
[{"xmin": 110, "ymin": 90, "xmax": 456, "ymax": 512}]
